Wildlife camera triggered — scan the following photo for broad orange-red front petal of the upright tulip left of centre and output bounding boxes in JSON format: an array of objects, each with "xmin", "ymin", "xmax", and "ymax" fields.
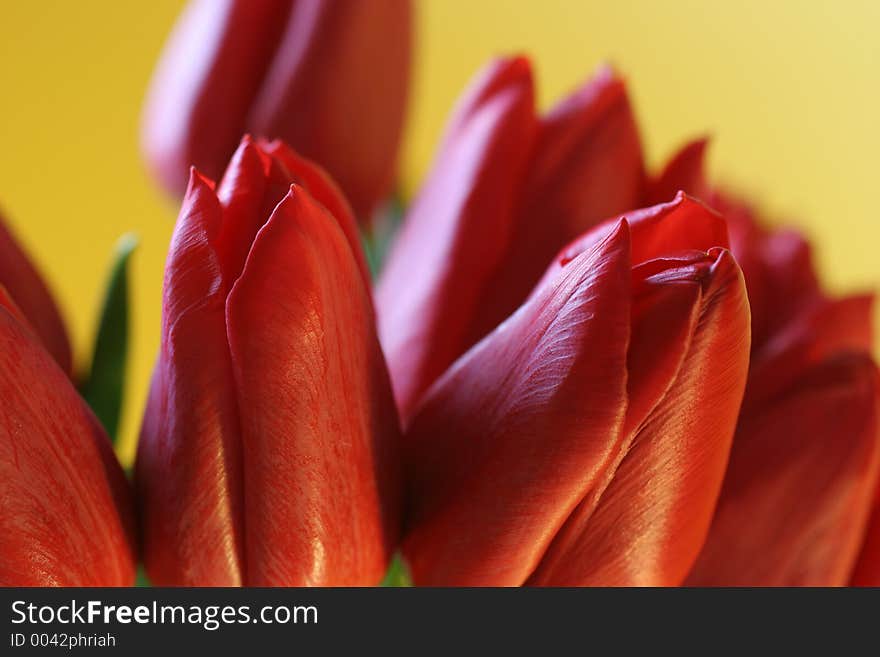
[{"xmin": 227, "ymin": 186, "xmax": 400, "ymax": 585}]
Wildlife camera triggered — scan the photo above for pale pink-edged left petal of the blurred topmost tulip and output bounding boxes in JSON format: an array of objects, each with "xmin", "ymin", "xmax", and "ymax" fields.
[{"xmin": 141, "ymin": 0, "xmax": 291, "ymax": 194}]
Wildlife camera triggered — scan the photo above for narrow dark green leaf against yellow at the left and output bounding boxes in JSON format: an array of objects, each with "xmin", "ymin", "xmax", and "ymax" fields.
[{"xmin": 80, "ymin": 233, "xmax": 138, "ymax": 444}]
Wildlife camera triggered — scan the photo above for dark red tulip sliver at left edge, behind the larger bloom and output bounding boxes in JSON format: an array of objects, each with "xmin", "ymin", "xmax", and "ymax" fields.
[{"xmin": 0, "ymin": 210, "xmax": 72, "ymax": 374}]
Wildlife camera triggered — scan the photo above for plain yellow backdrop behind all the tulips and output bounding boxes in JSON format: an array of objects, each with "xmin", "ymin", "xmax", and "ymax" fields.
[{"xmin": 0, "ymin": 0, "xmax": 880, "ymax": 459}]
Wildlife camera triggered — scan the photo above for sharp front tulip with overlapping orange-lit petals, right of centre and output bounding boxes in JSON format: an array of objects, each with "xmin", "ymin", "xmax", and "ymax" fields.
[{"xmin": 403, "ymin": 195, "xmax": 749, "ymax": 585}]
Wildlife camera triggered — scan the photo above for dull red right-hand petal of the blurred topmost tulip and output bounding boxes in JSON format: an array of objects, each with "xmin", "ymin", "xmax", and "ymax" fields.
[{"xmin": 248, "ymin": 0, "xmax": 412, "ymax": 219}]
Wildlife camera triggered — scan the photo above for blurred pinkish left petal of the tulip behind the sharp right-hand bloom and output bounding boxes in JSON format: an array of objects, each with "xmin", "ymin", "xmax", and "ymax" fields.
[{"xmin": 376, "ymin": 59, "xmax": 535, "ymax": 421}]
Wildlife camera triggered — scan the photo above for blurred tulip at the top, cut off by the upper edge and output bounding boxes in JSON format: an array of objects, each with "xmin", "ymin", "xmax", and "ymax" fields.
[{"xmin": 142, "ymin": 0, "xmax": 412, "ymax": 218}]
